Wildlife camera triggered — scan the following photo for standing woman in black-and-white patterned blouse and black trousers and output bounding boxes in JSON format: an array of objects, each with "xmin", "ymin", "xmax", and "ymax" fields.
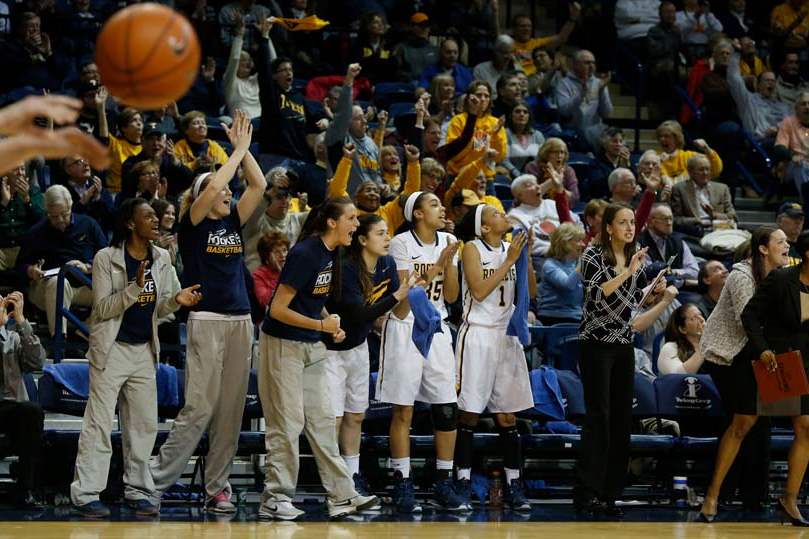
[{"xmin": 574, "ymin": 204, "xmax": 677, "ymax": 516}]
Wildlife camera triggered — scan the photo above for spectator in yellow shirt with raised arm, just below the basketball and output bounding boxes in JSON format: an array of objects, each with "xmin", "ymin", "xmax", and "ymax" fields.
[{"xmin": 95, "ymin": 86, "xmax": 143, "ymax": 193}]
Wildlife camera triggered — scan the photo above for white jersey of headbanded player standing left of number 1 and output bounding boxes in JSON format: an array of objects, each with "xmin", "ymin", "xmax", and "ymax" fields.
[{"xmin": 390, "ymin": 230, "xmax": 458, "ymax": 322}]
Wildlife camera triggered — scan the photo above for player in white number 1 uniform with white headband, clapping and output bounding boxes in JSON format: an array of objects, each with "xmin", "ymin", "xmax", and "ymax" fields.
[{"xmin": 455, "ymin": 204, "xmax": 537, "ymax": 511}]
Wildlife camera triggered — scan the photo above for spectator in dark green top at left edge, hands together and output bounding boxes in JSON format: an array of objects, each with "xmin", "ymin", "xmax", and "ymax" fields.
[{"xmin": 0, "ymin": 163, "xmax": 45, "ymax": 271}]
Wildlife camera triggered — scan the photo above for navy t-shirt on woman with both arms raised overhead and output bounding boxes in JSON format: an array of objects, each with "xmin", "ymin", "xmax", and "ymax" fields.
[{"xmin": 178, "ymin": 208, "xmax": 250, "ymax": 314}]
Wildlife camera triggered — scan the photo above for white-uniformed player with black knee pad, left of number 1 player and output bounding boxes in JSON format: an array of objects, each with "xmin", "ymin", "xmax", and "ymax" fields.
[{"xmin": 376, "ymin": 191, "xmax": 468, "ymax": 513}]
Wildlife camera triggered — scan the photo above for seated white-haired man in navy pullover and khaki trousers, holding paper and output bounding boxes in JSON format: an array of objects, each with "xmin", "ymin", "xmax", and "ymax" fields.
[{"xmin": 17, "ymin": 185, "xmax": 107, "ymax": 335}]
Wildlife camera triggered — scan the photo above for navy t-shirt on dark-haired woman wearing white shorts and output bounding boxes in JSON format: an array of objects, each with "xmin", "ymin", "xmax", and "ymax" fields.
[{"xmin": 324, "ymin": 256, "xmax": 399, "ymax": 350}]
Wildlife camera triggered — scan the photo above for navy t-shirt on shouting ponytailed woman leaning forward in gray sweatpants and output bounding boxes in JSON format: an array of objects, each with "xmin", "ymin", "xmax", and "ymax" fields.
[{"xmin": 261, "ymin": 236, "xmax": 337, "ymax": 342}]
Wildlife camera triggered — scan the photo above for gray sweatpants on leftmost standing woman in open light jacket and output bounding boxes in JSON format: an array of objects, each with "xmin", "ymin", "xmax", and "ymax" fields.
[{"xmin": 70, "ymin": 342, "xmax": 157, "ymax": 505}]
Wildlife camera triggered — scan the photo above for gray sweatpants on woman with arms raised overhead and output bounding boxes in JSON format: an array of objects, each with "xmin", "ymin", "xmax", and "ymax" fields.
[{"xmin": 152, "ymin": 319, "xmax": 253, "ymax": 499}]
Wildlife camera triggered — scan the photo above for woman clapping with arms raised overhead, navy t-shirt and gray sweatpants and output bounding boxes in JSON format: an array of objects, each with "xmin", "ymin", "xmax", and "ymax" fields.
[{"xmin": 152, "ymin": 111, "xmax": 266, "ymax": 513}]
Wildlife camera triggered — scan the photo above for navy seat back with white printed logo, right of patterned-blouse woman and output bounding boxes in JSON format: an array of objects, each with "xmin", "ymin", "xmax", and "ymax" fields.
[{"xmin": 654, "ymin": 374, "xmax": 724, "ymax": 417}]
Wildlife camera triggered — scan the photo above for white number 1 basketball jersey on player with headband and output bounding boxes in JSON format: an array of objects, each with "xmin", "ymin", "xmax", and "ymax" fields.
[{"xmin": 463, "ymin": 239, "xmax": 517, "ymax": 327}]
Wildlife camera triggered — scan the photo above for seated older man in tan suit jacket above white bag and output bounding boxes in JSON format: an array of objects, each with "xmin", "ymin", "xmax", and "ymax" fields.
[{"xmin": 671, "ymin": 155, "xmax": 736, "ymax": 236}]
